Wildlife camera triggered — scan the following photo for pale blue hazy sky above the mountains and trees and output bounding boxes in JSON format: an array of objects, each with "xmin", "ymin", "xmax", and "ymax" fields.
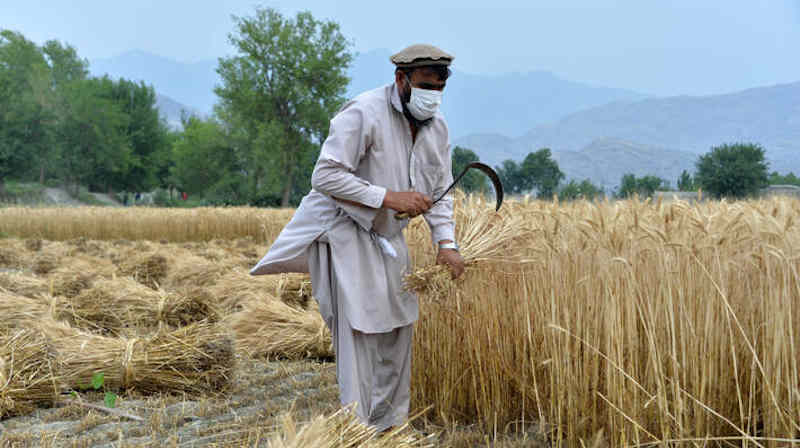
[{"xmin": 0, "ymin": 0, "xmax": 800, "ymax": 95}]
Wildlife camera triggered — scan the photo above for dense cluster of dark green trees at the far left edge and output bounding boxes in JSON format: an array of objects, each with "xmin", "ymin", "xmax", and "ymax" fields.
[{"xmin": 0, "ymin": 30, "xmax": 170, "ymax": 198}]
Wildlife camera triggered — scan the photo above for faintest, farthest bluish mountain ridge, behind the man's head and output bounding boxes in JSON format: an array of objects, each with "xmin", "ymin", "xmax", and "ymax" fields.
[{"xmin": 89, "ymin": 50, "xmax": 644, "ymax": 138}]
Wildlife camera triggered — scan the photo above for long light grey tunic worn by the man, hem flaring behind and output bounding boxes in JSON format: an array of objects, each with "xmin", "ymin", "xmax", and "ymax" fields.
[{"xmin": 250, "ymin": 84, "xmax": 454, "ymax": 333}]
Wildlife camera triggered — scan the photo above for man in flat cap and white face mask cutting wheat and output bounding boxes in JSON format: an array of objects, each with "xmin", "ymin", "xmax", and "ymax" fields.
[{"xmin": 251, "ymin": 45, "xmax": 464, "ymax": 431}]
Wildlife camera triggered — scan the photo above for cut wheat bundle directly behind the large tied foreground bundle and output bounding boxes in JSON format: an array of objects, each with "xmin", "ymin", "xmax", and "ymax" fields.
[{"xmin": 64, "ymin": 277, "xmax": 220, "ymax": 335}]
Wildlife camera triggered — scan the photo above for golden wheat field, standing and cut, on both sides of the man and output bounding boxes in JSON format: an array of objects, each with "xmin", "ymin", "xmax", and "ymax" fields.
[{"xmin": 0, "ymin": 196, "xmax": 800, "ymax": 447}]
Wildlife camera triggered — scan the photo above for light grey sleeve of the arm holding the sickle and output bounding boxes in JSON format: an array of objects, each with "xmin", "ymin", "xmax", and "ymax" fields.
[{"xmin": 311, "ymin": 103, "xmax": 386, "ymax": 229}]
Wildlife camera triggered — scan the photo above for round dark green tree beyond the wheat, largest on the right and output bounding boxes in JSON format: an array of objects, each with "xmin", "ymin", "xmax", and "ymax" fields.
[{"xmin": 695, "ymin": 143, "xmax": 768, "ymax": 198}]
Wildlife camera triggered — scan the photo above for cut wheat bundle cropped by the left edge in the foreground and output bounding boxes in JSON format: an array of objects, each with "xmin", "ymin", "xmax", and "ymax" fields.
[{"xmin": 0, "ymin": 329, "xmax": 59, "ymax": 418}]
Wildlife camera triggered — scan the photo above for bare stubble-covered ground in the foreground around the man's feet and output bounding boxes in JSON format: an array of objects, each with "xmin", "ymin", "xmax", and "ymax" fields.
[{"xmin": 0, "ymin": 359, "xmax": 548, "ymax": 448}]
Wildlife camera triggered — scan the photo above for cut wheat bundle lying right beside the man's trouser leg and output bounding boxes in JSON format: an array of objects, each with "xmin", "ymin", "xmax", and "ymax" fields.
[{"xmin": 226, "ymin": 297, "xmax": 333, "ymax": 359}]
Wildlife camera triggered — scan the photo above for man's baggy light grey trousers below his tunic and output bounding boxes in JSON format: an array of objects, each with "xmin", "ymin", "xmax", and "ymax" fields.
[{"xmin": 309, "ymin": 242, "xmax": 413, "ymax": 431}]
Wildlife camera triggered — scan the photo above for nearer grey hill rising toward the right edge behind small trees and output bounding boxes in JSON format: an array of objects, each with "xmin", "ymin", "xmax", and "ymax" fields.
[{"xmin": 455, "ymin": 83, "xmax": 800, "ymax": 186}]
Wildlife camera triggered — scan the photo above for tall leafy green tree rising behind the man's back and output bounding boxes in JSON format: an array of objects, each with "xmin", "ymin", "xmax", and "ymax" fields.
[{"xmin": 214, "ymin": 8, "xmax": 353, "ymax": 206}]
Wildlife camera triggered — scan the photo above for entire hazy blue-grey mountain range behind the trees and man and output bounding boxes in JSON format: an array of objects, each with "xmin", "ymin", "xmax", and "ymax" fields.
[{"xmin": 90, "ymin": 50, "xmax": 800, "ymax": 189}]
